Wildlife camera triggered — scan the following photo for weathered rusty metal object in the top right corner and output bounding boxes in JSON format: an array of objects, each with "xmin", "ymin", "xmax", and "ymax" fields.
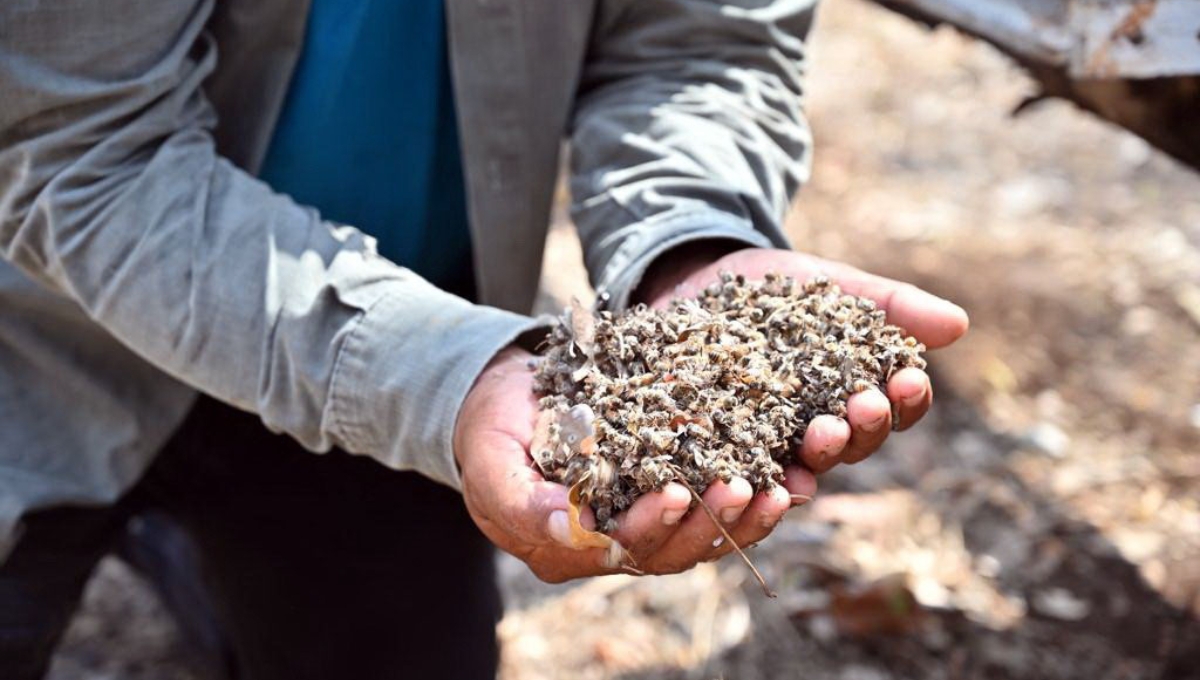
[{"xmin": 875, "ymin": 0, "xmax": 1200, "ymax": 169}]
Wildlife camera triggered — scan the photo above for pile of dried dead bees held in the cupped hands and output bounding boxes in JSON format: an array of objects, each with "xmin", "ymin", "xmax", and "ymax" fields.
[{"xmin": 532, "ymin": 275, "xmax": 925, "ymax": 532}]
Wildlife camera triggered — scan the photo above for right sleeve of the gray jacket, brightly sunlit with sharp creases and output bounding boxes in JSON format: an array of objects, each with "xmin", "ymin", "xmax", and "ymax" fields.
[{"xmin": 571, "ymin": 0, "xmax": 814, "ymax": 306}]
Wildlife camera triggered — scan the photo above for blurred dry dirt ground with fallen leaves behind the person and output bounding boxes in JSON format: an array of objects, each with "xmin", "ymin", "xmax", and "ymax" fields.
[{"xmin": 50, "ymin": 0, "xmax": 1200, "ymax": 680}]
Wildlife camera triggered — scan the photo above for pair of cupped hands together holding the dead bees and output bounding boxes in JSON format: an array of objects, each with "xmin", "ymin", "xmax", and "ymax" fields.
[{"xmin": 454, "ymin": 245, "xmax": 967, "ymax": 582}]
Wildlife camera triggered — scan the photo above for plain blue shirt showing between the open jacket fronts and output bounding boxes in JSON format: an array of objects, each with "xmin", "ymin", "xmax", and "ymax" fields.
[{"xmin": 260, "ymin": 0, "xmax": 474, "ymax": 297}]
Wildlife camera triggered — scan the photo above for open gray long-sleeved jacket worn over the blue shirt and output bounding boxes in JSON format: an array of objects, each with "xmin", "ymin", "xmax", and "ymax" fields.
[{"xmin": 0, "ymin": 0, "xmax": 812, "ymax": 556}]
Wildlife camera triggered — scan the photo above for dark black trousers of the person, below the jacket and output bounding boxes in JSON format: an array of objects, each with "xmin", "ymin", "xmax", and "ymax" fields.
[{"xmin": 0, "ymin": 398, "xmax": 500, "ymax": 680}]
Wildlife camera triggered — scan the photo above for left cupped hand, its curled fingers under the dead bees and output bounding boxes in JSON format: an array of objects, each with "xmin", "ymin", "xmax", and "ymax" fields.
[{"xmin": 454, "ymin": 348, "xmax": 816, "ymax": 583}]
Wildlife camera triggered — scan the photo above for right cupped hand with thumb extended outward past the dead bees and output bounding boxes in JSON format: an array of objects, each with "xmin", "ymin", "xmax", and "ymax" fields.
[{"xmin": 636, "ymin": 242, "xmax": 968, "ymax": 474}]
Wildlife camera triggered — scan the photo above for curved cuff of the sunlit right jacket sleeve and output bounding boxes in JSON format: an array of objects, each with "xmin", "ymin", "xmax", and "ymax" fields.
[{"xmin": 596, "ymin": 210, "xmax": 787, "ymax": 309}]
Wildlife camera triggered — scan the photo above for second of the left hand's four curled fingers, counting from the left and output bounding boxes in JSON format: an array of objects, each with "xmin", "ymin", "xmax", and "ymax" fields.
[{"xmin": 646, "ymin": 477, "xmax": 754, "ymax": 573}]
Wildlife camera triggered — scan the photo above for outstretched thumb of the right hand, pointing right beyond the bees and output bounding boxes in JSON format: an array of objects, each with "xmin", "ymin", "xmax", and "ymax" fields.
[{"xmin": 792, "ymin": 258, "xmax": 970, "ymax": 349}]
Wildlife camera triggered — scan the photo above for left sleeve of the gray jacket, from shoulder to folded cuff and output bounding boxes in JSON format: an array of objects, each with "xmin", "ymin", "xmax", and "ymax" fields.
[{"xmin": 0, "ymin": 0, "xmax": 536, "ymax": 485}]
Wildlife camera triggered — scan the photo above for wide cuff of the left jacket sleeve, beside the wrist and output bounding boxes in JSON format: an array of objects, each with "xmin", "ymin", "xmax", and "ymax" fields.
[{"xmin": 324, "ymin": 287, "xmax": 546, "ymax": 489}]
